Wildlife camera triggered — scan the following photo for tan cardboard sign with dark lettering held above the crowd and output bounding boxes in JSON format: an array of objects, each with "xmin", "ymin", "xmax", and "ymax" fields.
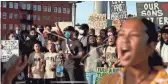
[{"xmin": 88, "ymin": 14, "xmax": 107, "ymax": 35}]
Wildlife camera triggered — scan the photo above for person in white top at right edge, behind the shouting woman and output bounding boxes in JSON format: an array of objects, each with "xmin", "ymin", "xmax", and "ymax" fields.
[{"xmin": 156, "ymin": 25, "xmax": 168, "ymax": 66}]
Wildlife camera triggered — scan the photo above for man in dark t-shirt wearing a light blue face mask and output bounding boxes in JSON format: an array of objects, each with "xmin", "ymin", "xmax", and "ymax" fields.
[{"xmin": 61, "ymin": 26, "xmax": 84, "ymax": 81}]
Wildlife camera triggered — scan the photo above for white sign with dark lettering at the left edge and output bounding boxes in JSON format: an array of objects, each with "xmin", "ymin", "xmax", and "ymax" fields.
[{"xmin": 1, "ymin": 40, "xmax": 19, "ymax": 62}]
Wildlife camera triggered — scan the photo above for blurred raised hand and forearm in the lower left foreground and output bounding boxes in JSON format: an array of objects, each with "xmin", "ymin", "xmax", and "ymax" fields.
[{"xmin": 4, "ymin": 56, "xmax": 27, "ymax": 84}]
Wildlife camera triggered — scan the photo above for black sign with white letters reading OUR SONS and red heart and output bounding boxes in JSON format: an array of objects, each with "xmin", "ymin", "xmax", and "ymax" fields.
[{"xmin": 136, "ymin": 2, "xmax": 168, "ymax": 26}]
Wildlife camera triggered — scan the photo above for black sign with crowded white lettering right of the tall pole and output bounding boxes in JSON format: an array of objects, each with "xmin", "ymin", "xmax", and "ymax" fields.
[{"xmin": 109, "ymin": 1, "xmax": 127, "ymax": 20}]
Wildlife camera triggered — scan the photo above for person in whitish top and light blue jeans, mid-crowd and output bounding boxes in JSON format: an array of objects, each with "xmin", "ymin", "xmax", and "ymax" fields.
[{"xmin": 84, "ymin": 35, "xmax": 101, "ymax": 84}]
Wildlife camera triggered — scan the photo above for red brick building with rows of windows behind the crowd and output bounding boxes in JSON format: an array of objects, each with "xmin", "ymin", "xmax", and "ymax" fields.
[{"xmin": 1, "ymin": 1, "xmax": 72, "ymax": 39}]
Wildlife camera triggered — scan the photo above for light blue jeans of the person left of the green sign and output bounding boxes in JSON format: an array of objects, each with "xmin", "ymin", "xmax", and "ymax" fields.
[{"xmin": 85, "ymin": 72, "xmax": 97, "ymax": 84}]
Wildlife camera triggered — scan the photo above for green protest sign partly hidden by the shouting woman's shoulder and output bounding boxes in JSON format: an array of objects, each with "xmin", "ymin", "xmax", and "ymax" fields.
[{"xmin": 96, "ymin": 67, "xmax": 121, "ymax": 84}]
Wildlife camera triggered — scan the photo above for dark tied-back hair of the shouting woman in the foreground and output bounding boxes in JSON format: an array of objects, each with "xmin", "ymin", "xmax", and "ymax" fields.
[{"xmin": 134, "ymin": 18, "xmax": 164, "ymax": 69}]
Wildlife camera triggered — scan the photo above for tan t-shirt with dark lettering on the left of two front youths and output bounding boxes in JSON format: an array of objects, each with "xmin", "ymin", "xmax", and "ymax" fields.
[{"xmin": 28, "ymin": 52, "xmax": 44, "ymax": 78}]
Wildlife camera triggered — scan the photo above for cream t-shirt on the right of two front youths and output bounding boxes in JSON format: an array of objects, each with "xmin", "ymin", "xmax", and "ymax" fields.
[{"xmin": 44, "ymin": 52, "xmax": 61, "ymax": 79}]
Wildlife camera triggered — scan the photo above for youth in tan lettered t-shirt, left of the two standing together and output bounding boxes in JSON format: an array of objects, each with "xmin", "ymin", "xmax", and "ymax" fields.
[{"xmin": 28, "ymin": 43, "xmax": 45, "ymax": 84}]
